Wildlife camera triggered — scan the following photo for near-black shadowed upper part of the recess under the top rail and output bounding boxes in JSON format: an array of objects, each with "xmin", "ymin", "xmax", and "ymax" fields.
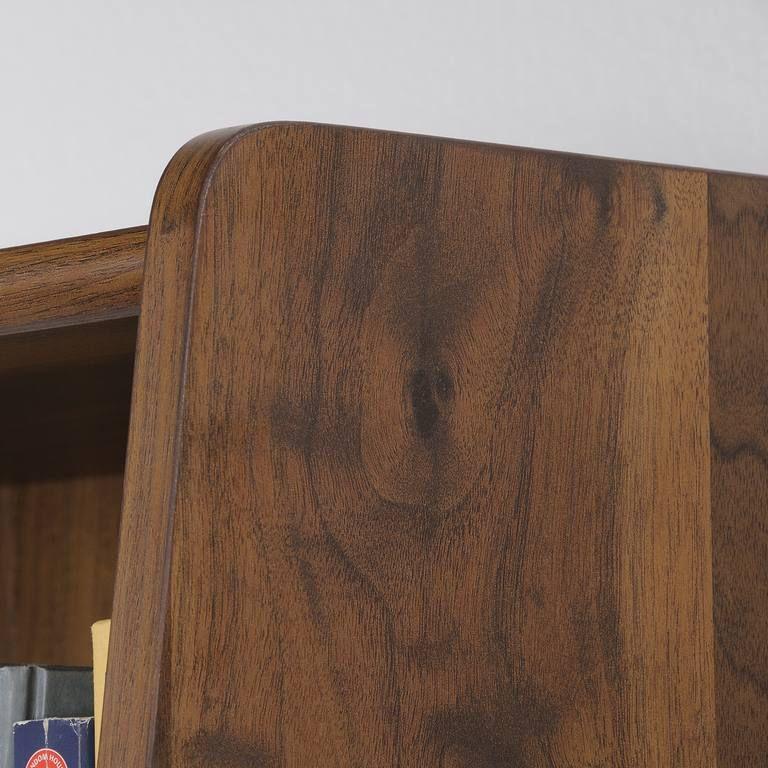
[{"xmin": 0, "ymin": 318, "xmax": 136, "ymax": 483}]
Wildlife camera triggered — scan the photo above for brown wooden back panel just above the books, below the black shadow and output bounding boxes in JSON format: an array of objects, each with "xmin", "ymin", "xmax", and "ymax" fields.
[{"xmin": 0, "ymin": 473, "xmax": 123, "ymax": 666}]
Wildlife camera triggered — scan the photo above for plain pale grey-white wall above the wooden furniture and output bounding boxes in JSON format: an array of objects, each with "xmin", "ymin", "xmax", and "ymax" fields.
[{"xmin": 0, "ymin": 0, "xmax": 768, "ymax": 246}]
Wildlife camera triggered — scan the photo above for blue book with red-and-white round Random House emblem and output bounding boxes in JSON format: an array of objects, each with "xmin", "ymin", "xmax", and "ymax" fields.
[{"xmin": 13, "ymin": 717, "xmax": 95, "ymax": 768}]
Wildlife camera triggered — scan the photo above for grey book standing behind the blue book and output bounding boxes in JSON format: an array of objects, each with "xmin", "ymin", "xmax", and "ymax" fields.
[{"xmin": 0, "ymin": 665, "xmax": 93, "ymax": 768}]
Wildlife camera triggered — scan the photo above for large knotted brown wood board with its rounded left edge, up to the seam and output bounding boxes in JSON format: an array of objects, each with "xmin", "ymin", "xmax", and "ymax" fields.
[{"xmin": 101, "ymin": 124, "xmax": 715, "ymax": 768}]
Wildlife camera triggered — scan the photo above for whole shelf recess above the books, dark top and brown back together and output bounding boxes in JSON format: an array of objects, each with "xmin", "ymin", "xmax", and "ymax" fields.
[{"xmin": 0, "ymin": 318, "xmax": 136, "ymax": 665}]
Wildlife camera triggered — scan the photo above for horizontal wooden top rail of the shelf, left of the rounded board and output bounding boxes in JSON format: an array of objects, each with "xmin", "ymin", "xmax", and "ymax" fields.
[{"xmin": 0, "ymin": 227, "xmax": 146, "ymax": 335}]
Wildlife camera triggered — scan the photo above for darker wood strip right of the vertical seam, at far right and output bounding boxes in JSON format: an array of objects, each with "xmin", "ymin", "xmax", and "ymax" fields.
[{"xmin": 709, "ymin": 174, "xmax": 768, "ymax": 768}]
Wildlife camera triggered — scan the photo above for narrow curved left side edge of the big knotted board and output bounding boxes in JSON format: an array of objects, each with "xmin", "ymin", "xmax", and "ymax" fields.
[{"xmin": 99, "ymin": 123, "xmax": 273, "ymax": 768}]
